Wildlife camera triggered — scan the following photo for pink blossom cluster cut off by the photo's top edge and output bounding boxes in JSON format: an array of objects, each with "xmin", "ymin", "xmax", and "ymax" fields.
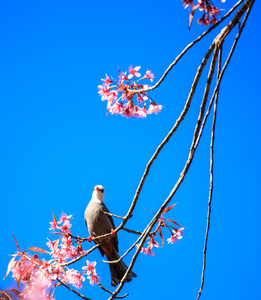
[{"xmin": 181, "ymin": 0, "xmax": 226, "ymax": 28}]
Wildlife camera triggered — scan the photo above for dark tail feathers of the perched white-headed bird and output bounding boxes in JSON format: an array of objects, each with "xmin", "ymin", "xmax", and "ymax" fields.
[{"xmin": 106, "ymin": 249, "xmax": 137, "ymax": 286}]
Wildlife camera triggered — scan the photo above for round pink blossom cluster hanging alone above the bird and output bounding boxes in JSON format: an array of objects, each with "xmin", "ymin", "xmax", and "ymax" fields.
[{"xmin": 98, "ymin": 66, "xmax": 162, "ymax": 118}]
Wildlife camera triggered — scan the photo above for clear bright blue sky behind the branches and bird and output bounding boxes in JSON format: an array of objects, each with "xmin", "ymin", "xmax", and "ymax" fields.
[{"xmin": 0, "ymin": 0, "xmax": 261, "ymax": 300}]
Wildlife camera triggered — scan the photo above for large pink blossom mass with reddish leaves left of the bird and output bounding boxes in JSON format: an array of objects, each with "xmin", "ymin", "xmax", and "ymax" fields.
[{"xmin": 6, "ymin": 214, "xmax": 99, "ymax": 300}]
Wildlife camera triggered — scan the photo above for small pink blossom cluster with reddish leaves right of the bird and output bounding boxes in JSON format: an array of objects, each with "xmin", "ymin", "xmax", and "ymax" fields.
[{"xmin": 137, "ymin": 204, "xmax": 184, "ymax": 256}]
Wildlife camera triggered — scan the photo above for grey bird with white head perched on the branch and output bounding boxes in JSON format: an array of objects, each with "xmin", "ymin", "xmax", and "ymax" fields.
[{"xmin": 84, "ymin": 185, "xmax": 137, "ymax": 286}]
